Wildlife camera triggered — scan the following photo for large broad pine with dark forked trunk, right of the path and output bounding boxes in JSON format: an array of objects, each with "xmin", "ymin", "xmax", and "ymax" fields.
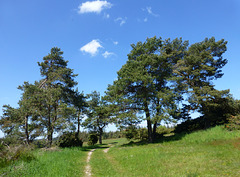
[{"xmin": 107, "ymin": 37, "xmax": 183, "ymax": 142}]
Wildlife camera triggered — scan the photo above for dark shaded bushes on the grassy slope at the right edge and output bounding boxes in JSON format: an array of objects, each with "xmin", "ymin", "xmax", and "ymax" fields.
[{"xmin": 175, "ymin": 96, "xmax": 240, "ymax": 133}]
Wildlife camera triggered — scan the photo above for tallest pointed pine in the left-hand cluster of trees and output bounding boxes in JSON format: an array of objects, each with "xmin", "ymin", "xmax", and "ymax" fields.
[{"xmin": 38, "ymin": 47, "xmax": 77, "ymax": 146}]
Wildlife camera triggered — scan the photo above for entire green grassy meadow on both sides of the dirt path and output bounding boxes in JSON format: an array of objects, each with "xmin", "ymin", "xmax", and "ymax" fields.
[{"xmin": 0, "ymin": 126, "xmax": 240, "ymax": 177}]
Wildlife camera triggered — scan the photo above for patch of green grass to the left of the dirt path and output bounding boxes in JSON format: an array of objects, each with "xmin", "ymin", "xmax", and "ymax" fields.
[{"xmin": 0, "ymin": 148, "xmax": 87, "ymax": 177}]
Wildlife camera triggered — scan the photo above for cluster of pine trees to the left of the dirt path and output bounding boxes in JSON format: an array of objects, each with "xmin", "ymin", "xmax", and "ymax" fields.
[{"xmin": 0, "ymin": 48, "xmax": 109, "ymax": 146}]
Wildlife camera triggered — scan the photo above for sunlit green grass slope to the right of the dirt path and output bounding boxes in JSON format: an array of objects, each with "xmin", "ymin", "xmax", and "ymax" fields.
[{"xmin": 91, "ymin": 127, "xmax": 240, "ymax": 177}]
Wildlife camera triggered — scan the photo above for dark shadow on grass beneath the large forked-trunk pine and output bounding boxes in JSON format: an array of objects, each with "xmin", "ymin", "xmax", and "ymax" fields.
[{"xmin": 121, "ymin": 133, "xmax": 186, "ymax": 147}]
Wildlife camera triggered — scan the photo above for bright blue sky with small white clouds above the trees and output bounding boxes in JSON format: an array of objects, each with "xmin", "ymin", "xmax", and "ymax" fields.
[{"xmin": 0, "ymin": 0, "xmax": 240, "ymax": 136}]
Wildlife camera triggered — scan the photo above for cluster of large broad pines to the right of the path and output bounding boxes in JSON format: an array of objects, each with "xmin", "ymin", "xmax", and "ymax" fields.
[{"xmin": 107, "ymin": 37, "xmax": 230, "ymax": 142}]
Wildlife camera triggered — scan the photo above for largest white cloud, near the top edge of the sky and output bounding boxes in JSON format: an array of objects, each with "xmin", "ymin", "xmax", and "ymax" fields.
[{"xmin": 78, "ymin": 0, "xmax": 112, "ymax": 14}]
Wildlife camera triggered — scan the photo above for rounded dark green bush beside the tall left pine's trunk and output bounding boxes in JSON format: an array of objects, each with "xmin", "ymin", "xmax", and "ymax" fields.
[{"xmin": 57, "ymin": 132, "xmax": 83, "ymax": 148}]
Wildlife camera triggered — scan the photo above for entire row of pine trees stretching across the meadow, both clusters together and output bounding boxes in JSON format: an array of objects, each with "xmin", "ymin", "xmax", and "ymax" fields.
[{"xmin": 0, "ymin": 37, "xmax": 236, "ymax": 145}]
